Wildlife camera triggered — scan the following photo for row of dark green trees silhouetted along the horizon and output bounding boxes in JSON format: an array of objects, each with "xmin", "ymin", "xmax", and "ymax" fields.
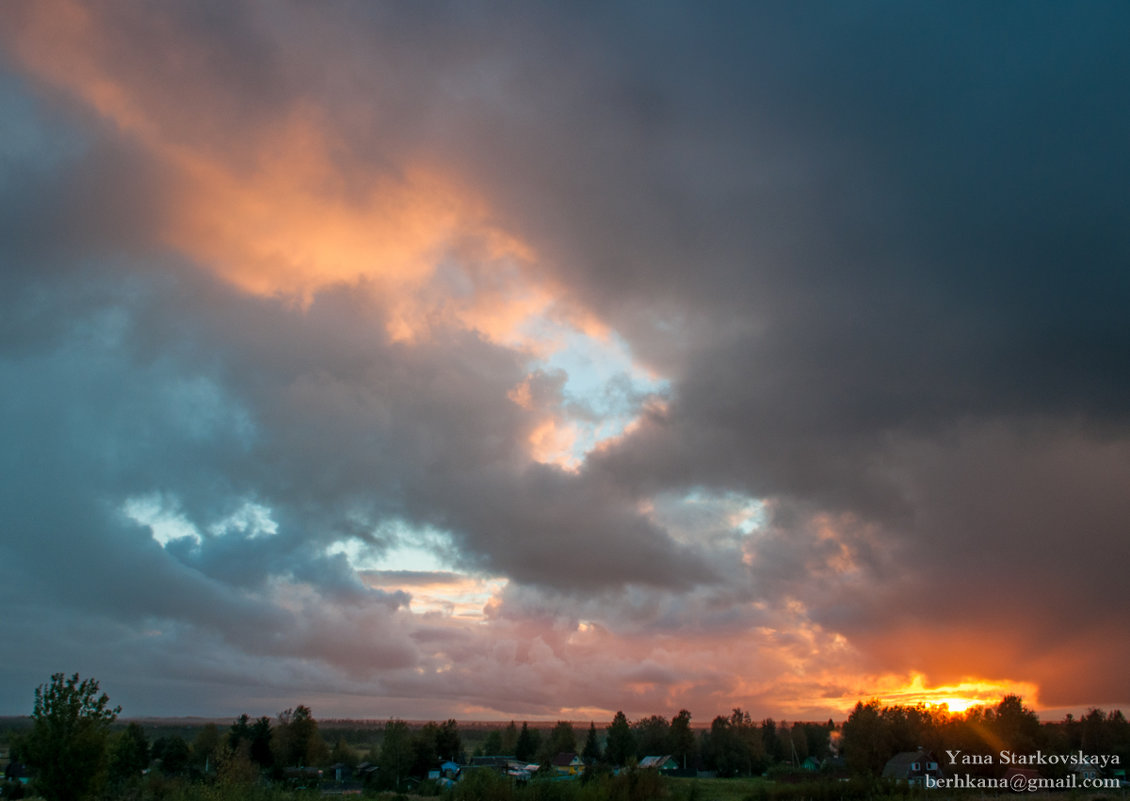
[{"xmin": 5, "ymin": 673, "xmax": 1130, "ymax": 801}]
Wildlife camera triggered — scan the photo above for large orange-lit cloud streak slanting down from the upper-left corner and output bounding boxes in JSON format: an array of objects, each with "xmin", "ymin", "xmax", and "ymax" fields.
[{"xmin": 4, "ymin": 0, "xmax": 556, "ymax": 341}]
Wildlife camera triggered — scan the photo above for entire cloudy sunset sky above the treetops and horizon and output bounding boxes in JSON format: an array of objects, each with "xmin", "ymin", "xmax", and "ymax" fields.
[{"xmin": 0, "ymin": 0, "xmax": 1130, "ymax": 724}]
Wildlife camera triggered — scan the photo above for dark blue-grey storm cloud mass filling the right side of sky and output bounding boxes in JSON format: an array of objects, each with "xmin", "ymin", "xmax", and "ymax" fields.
[{"xmin": 397, "ymin": 5, "xmax": 1130, "ymax": 700}]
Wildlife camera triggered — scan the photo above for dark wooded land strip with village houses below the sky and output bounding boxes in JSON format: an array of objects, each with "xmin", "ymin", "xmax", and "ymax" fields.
[{"xmin": 0, "ymin": 674, "xmax": 1130, "ymax": 801}]
